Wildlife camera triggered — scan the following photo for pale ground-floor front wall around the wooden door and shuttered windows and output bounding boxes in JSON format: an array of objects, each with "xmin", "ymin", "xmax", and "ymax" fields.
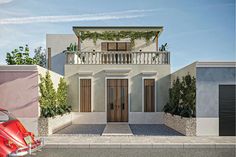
[{"xmin": 65, "ymin": 65, "xmax": 170, "ymax": 123}]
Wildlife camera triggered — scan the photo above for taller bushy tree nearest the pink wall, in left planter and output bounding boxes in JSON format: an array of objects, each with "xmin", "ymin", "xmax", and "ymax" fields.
[{"xmin": 39, "ymin": 71, "xmax": 57, "ymax": 117}]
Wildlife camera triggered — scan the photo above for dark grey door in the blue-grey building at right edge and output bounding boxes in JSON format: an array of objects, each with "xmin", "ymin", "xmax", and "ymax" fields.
[{"xmin": 219, "ymin": 85, "xmax": 236, "ymax": 136}]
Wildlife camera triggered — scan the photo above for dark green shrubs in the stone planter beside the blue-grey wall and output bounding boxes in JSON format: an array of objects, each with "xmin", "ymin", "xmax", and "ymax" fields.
[{"xmin": 163, "ymin": 74, "xmax": 196, "ymax": 117}]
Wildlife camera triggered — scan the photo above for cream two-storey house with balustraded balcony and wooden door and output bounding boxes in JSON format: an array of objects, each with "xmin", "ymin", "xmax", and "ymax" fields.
[{"xmin": 47, "ymin": 27, "xmax": 170, "ymax": 124}]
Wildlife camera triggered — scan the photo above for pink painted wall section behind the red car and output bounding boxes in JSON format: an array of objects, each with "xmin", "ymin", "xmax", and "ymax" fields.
[{"xmin": 0, "ymin": 71, "xmax": 39, "ymax": 117}]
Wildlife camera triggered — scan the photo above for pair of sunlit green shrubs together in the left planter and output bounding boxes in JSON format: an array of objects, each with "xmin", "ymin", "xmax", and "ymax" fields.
[{"xmin": 39, "ymin": 71, "xmax": 71, "ymax": 118}]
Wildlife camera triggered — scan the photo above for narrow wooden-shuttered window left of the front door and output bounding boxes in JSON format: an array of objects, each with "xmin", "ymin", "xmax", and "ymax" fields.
[{"xmin": 80, "ymin": 79, "xmax": 91, "ymax": 112}]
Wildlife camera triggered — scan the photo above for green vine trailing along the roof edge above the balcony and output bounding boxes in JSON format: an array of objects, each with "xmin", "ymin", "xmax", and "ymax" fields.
[{"xmin": 80, "ymin": 31, "xmax": 156, "ymax": 47}]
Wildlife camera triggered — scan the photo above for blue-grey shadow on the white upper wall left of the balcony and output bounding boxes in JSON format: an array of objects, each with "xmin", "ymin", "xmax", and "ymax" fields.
[{"xmin": 46, "ymin": 52, "xmax": 66, "ymax": 76}]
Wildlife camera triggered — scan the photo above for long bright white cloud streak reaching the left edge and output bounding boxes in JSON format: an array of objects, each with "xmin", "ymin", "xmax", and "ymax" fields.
[{"xmin": 0, "ymin": 10, "xmax": 151, "ymax": 25}]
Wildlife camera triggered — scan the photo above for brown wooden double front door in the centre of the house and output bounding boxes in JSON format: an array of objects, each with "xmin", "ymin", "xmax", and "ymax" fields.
[{"xmin": 107, "ymin": 79, "xmax": 129, "ymax": 122}]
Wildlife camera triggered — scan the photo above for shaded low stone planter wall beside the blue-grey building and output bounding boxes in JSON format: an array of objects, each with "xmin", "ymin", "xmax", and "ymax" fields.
[{"xmin": 164, "ymin": 113, "xmax": 196, "ymax": 136}]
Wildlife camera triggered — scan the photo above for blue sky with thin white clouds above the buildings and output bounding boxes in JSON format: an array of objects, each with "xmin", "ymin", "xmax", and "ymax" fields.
[{"xmin": 0, "ymin": 0, "xmax": 235, "ymax": 71}]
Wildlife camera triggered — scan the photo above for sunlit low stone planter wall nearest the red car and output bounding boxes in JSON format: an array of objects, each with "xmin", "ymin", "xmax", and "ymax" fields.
[{"xmin": 38, "ymin": 113, "xmax": 72, "ymax": 136}]
